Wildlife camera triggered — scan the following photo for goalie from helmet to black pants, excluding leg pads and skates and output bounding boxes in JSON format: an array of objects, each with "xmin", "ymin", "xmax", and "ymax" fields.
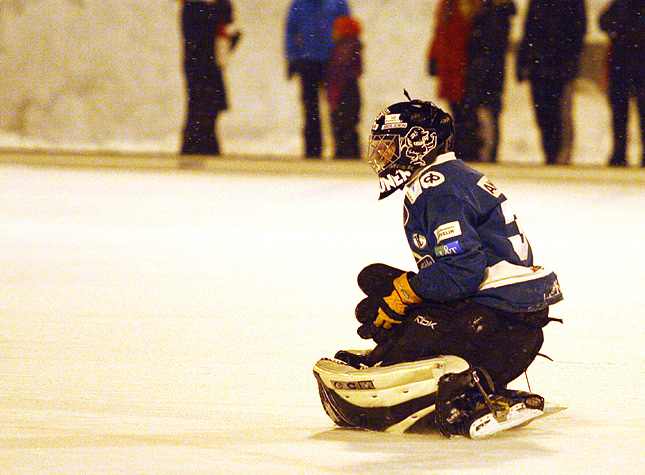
[{"xmin": 336, "ymin": 96, "xmax": 562, "ymax": 388}]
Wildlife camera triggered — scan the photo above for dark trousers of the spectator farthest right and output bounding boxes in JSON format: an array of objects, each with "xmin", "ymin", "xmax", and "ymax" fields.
[{"xmin": 608, "ymin": 65, "xmax": 645, "ymax": 166}]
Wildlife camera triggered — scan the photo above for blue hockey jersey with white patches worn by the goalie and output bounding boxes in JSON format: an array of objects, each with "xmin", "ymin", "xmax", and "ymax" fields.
[{"xmin": 404, "ymin": 152, "xmax": 562, "ymax": 312}]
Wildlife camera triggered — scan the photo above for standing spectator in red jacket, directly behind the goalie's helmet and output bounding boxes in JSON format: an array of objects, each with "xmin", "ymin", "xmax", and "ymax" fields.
[{"xmin": 427, "ymin": 0, "xmax": 483, "ymax": 161}]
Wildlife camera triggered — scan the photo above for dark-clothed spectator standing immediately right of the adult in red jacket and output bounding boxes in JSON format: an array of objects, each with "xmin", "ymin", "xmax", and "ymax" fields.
[{"xmin": 464, "ymin": 0, "xmax": 517, "ymax": 162}]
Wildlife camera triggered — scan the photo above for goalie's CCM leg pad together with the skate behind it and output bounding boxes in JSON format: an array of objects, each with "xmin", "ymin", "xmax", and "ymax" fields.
[{"xmin": 314, "ymin": 351, "xmax": 544, "ymax": 439}]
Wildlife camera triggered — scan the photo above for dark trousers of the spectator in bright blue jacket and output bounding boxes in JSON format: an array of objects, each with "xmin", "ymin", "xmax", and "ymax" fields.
[{"xmin": 297, "ymin": 61, "xmax": 325, "ymax": 158}]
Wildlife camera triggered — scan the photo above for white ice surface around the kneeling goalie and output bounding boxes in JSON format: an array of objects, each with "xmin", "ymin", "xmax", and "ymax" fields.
[{"xmin": 0, "ymin": 163, "xmax": 645, "ymax": 475}]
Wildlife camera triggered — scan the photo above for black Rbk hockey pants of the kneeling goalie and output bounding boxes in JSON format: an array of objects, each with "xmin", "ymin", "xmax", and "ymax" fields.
[{"xmin": 369, "ymin": 301, "xmax": 548, "ymax": 387}]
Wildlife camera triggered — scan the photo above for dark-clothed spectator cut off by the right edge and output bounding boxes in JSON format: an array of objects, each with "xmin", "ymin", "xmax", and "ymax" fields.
[{"xmin": 599, "ymin": 0, "xmax": 645, "ymax": 167}]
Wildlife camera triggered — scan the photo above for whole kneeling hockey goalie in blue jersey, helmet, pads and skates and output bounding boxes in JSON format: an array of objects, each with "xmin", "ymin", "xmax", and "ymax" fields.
[{"xmin": 314, "ymin": 93, "xmax": 562, "ymax": 438}]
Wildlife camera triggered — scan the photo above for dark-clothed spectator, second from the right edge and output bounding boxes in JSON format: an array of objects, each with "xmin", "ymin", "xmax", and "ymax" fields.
[{"xmin": 516, "ymin": 0, "xmax": 587, "ymax": 164}]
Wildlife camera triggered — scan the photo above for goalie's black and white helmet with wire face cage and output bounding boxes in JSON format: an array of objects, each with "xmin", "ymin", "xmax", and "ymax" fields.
[{"xmin": 367, "ymin": 94, "xmax": 455, "ymax": 199}]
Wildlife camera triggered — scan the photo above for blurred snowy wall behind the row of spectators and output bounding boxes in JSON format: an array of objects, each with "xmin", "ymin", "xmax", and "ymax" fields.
[{"xmin": 0, "ymin": 0, "xmax": 628, "ymax": 162}]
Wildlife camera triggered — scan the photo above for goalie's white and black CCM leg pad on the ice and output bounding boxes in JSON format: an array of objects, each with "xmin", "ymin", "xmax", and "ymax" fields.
[{"xmin": 314, "ymin": 356, "xmax": 470, "ymax": 432}]
